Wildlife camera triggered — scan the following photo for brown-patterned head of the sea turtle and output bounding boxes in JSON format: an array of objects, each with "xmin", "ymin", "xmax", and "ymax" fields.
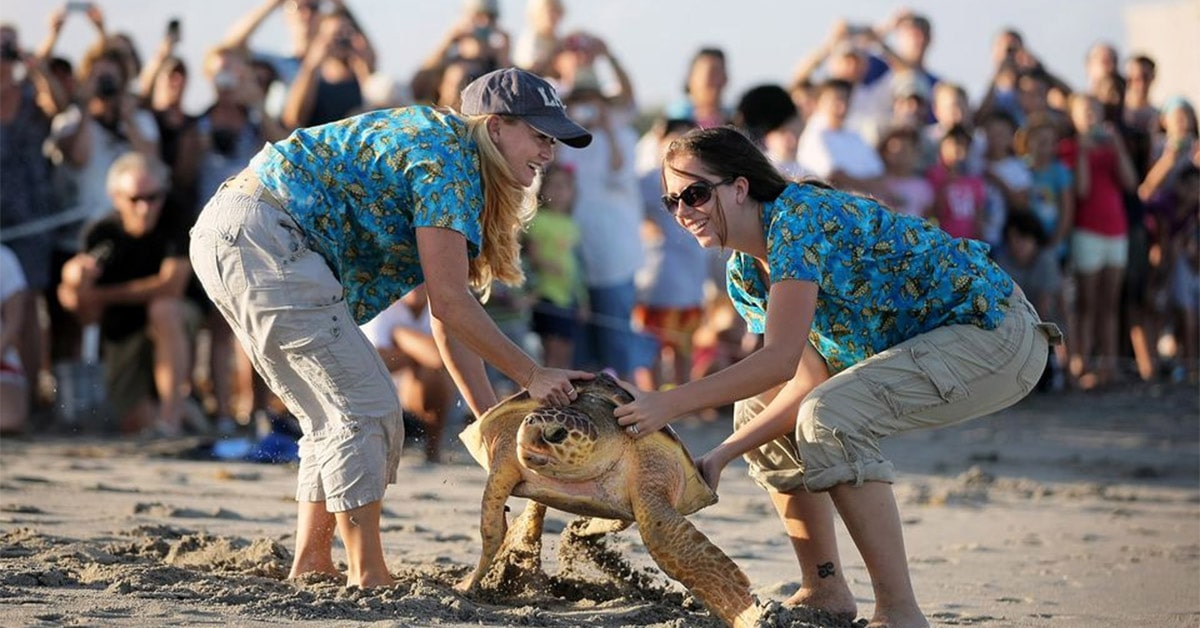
[{"xmin": 517, "ymin": 406, "xmax": 625, "ymax": 482}]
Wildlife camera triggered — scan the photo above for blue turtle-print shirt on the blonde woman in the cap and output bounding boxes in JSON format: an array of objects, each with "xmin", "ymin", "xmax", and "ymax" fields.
[{"xmin": 251, "ymin": 107, "xmax": 484, "ymax": 324}]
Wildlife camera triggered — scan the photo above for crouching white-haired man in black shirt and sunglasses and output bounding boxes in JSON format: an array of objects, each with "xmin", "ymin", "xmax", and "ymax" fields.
[{"xmin": 59, "ymin": 152, "xmax": 203, "ymax": 436}]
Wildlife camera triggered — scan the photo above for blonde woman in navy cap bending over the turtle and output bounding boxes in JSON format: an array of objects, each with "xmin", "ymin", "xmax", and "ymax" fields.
[{"xmin": 191, "ymin": 70, "xmax": 592, "ymax": 587}]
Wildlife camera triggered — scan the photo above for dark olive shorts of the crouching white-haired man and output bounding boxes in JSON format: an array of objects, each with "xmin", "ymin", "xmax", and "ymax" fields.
[{"xmin": 103, "ymin": 299, "xmax": 202, "ymax": 417}]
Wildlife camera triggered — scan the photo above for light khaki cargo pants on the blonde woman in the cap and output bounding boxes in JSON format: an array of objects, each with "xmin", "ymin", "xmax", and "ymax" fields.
[{"xmin": 191, "ymin": 170, "xmax": 404, "ymax": 513}]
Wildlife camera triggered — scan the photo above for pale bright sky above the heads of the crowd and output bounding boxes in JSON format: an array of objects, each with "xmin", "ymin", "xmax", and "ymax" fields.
[{"xmin": 0, "ymin": 0, "xmax": 1150, "ymax": 110}]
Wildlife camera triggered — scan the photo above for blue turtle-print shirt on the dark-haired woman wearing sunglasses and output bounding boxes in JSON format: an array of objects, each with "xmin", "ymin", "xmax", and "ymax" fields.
[{"xmin": 726, "ymin": 184, "xmax": 1013, "ymax": 372}]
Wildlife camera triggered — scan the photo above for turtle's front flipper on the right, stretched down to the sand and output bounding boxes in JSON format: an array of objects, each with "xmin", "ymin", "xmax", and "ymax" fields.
[{"xmin": 634, "ymin": 491, "xmax": 760, "ymax": 628}]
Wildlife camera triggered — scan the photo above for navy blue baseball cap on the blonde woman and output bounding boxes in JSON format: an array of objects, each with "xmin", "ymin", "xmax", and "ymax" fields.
[{"xmin": 462, "ymin": 67, "xmax": 592, "ymax": 148}]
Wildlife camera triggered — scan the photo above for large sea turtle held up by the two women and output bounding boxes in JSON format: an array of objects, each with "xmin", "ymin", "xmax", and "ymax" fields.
[{"xmin": 460, "ymin": 373, "xmax": 758, "ymax": 627}]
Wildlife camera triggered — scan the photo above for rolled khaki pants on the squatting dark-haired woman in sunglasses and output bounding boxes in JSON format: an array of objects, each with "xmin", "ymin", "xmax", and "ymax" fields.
[{"xmin": 733, "ymin": 294, "xmax": 1061, "ymax": 492}]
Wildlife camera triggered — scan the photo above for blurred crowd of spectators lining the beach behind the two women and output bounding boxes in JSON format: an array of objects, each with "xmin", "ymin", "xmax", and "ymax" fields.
[{"xmin": 0, "ymin": 0, "xmax": 1200, "ymax": 451}]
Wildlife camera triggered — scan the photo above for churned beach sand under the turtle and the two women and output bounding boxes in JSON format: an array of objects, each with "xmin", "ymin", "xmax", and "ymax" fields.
[{"xmin": 0, "ymin": 385, "xmax": 1200, "ymax": 628}]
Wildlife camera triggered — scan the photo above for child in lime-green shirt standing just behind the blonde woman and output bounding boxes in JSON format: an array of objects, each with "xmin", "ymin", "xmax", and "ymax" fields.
[{"xmin": 524, "ymin": 162, "xmax": 586, "ymax": 369}]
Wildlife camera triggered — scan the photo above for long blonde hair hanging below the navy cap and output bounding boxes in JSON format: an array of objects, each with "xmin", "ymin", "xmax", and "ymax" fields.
[{"xmin": 466, "ymin": 114, "xmax": 536, "ymax": 301}]
